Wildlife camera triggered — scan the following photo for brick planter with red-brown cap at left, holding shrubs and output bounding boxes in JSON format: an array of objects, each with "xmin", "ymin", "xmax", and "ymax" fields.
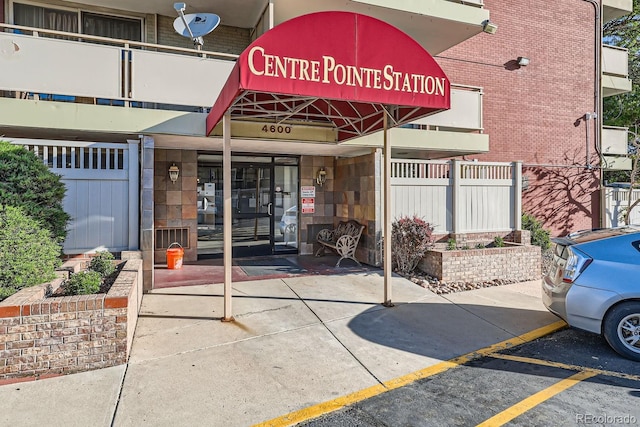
[{"xmin": 0, "ymin": 259, "xmax": 142, "ymax": 379}]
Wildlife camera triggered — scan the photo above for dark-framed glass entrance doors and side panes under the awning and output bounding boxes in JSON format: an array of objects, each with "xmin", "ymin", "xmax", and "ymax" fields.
[{"xmin": 197, "ymin": 154, "xmax": 298, "ymax": 257}]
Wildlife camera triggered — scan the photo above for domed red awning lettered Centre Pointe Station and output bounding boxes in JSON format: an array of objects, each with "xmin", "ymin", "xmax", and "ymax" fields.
[{"xmin": 207, "ymin": 12, "xmax": 450, "ymax": 142}]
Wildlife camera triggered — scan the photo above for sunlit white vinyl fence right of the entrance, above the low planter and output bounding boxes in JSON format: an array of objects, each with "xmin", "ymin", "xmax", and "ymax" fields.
[{"xmin": 391, "ymin": 159, "xmax": 522, "ymax": 234}]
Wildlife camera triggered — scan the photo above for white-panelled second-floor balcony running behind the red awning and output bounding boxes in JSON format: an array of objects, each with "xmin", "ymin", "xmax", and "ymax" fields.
[{"xmin": 0, "ymin": 24, "xmax": 488, "ymax": 157}]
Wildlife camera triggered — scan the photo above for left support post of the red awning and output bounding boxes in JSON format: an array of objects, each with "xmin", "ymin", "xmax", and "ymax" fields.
[{"xmin": 222, "ymin": 111, "xmax": 234, "ymax": 322}]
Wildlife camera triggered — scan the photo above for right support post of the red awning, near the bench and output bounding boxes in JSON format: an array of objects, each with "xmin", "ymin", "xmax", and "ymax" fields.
[{"xmin": 382, "ymin": 108, "xmax": 393, "ymax": 307}]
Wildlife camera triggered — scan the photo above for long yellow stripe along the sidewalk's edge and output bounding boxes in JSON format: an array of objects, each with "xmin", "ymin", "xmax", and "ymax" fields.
[{"xmin": 253, "ymin": 321, "xmax": 567, "ymax": 427}]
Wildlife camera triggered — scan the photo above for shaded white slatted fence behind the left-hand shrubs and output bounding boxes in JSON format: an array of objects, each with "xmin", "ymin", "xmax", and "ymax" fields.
[{"xmin": 10, "ymin": 139, "xmax": 139, "ymax": 254}]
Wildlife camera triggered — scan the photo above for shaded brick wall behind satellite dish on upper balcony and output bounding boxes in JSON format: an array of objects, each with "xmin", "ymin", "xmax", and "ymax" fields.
[{"xmin": 157, "ymin": 16, "xmax": 251, "ymax": 55}]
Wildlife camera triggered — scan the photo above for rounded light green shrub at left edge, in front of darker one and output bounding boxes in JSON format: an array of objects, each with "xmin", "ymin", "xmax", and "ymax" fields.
[{"xmin": 0, "ymin": 205, "xmax": 60, "ymax": 299}]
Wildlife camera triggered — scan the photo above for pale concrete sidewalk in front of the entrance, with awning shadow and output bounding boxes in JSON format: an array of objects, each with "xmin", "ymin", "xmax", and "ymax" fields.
[{"xmin": 0, "ymin": 273, "xmax": 558, "ymax": 426}]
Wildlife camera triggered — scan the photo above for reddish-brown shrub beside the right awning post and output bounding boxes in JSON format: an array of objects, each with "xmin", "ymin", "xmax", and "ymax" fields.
[{"xmin": 391, "ymin": 216, "xmax": 433, "ymax": 274}]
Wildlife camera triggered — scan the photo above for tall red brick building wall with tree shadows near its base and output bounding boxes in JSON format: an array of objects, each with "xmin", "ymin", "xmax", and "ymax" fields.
[{"xmin": 436, "ymin": 0, "xmax": 599, "ymax": 234}]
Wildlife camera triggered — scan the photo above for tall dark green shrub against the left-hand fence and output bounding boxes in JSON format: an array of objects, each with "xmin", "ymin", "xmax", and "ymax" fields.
[{"xmin": 0, "ymin": 141, "xmax": 69, "ymax": 243}]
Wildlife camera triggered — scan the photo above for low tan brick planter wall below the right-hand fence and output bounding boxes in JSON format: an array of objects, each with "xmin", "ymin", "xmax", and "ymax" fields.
[{"xmin": 419, "ymin": 246, "xmax": 542, "ymax": 282}]
